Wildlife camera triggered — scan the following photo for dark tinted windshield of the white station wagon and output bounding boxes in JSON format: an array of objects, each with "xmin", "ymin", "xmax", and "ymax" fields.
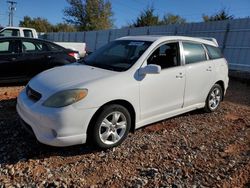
[{"xmin": 82, "ymin": 40, "xmax": 152, "ymax": 72}]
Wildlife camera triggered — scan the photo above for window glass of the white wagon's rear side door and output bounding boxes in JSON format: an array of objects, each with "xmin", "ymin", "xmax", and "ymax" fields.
[{"xmin": 182, "ymin": 42, "xmax": 207, "ymax": 64}]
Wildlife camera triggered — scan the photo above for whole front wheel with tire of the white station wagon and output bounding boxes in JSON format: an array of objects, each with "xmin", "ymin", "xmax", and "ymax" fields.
[{"xmin": 92, "ymin": 105, "xmax": 131, "ymax": 149}]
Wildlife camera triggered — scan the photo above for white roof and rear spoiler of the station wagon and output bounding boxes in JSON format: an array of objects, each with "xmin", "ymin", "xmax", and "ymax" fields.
[{"xmin": 117, "ymin": 35, "xmax": 218, "ymax": 46}]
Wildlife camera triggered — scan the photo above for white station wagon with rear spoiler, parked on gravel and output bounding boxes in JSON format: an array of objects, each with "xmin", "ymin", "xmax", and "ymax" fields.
[{"xmin": 17, "ymin": 36, "xmax": 228, "ymax": 149}]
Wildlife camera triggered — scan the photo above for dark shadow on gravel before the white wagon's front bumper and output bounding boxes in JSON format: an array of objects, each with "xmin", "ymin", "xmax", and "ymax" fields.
[{"xmin": 0, "ymin": 99, "xmax": 100, "ymax": 164}]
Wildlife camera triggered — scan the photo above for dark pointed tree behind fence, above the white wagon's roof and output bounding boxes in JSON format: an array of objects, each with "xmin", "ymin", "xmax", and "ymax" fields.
[{"xmin": 131, "ymin": 7, "xmax": 160, "ymax": 27}]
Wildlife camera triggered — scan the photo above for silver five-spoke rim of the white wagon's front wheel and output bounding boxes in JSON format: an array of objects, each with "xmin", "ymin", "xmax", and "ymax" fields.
[{"xmin": 99, "ymin": 111, "xmax": 127, "ymax": 145}]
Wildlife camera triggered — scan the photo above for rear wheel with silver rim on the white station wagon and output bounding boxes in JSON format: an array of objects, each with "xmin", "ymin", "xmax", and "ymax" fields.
[{"xmin": 204, "ymin": 84, "xmax": 223, "ymax": 112}]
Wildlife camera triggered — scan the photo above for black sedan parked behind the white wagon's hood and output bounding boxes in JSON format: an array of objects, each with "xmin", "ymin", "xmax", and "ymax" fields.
[{"xmin": 0, "ymin": 37, "xmax": 79, "ymax": 83}]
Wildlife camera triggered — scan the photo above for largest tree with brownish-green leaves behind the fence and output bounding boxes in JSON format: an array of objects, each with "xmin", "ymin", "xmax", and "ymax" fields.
[{"xmin": 63, "ymin": 0, "xmax": 113, "ymax": 31}]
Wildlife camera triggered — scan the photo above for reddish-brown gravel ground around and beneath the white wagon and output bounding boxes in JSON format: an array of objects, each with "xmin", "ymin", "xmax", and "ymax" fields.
[{"xmin": 0, "ymin": 80, "xmax": 250, "ymax": 188}]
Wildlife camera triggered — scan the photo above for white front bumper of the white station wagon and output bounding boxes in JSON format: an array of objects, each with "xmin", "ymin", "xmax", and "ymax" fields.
[{"xmin": 17, "ymin": 91, "xmax": 96, "ymax": 147}]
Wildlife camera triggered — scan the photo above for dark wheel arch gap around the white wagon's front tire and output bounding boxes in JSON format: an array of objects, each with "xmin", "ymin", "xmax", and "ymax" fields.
[{"xmin": 87, "ymin": 99, "xmax": 136, "ymax": 140}]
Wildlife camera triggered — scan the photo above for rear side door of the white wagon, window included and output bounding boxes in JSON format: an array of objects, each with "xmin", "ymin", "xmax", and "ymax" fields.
[{"xmin": 182, "ymin": 41, "xmax": 214, "ymax": 107}]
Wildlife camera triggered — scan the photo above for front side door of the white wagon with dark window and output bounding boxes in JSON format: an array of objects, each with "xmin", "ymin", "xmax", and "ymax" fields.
[{"xmin": 140, "ymin": 42, "xmax": 185, "ymax": 120}]
